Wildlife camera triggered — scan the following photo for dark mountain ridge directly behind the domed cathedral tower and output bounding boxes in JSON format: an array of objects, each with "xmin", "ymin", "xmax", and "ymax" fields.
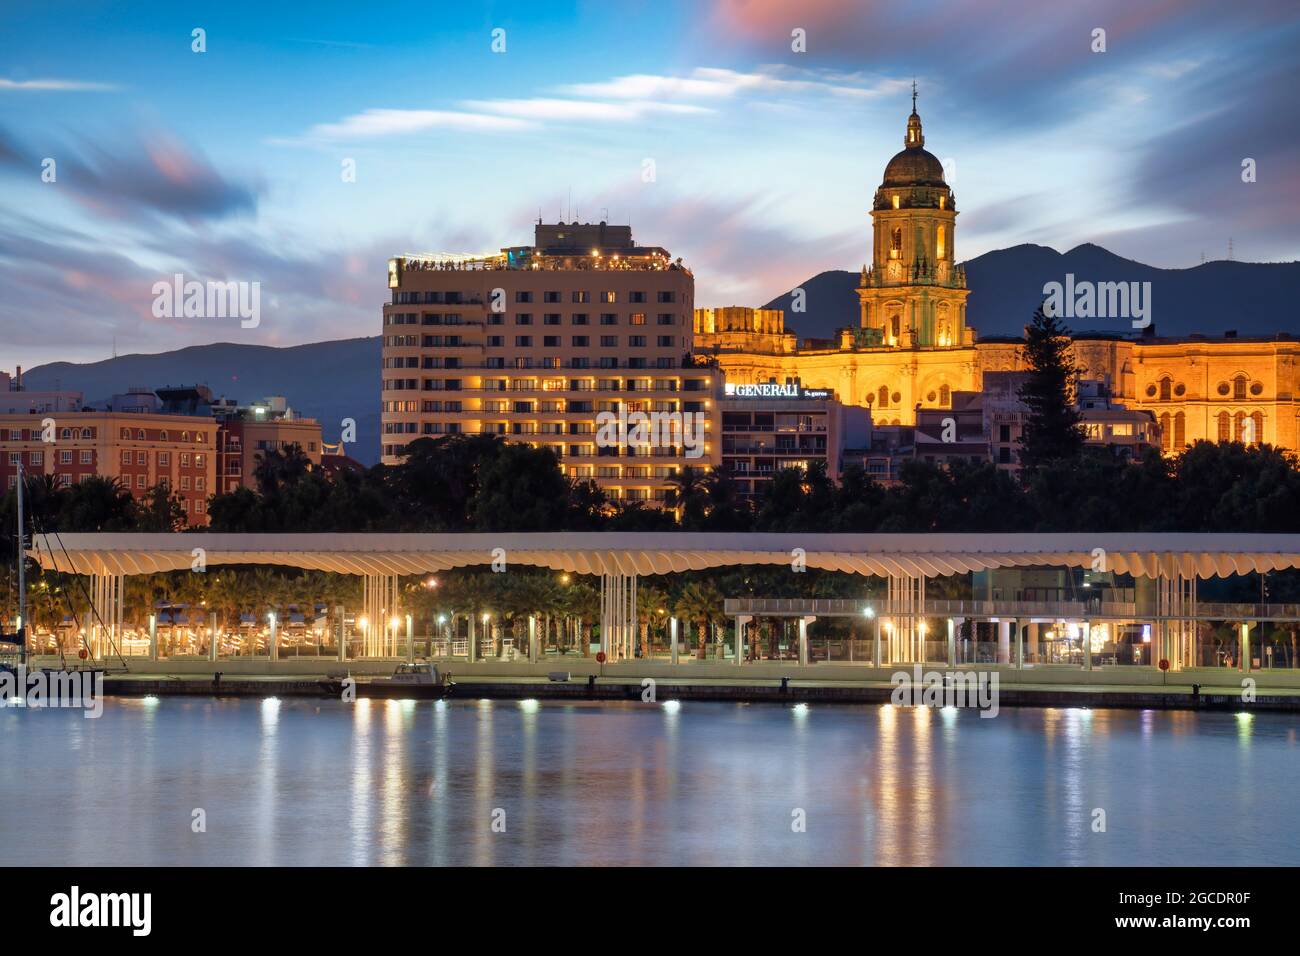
[{"xmin": 763, "ymin": 243, "xmax": 1300, "ymax": 339}]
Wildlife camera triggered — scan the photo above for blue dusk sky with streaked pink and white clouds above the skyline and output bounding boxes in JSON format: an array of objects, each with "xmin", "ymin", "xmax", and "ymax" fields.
[{"xmin": 0, "ymin": 0, "xmax": 1300, "ymax": 371}]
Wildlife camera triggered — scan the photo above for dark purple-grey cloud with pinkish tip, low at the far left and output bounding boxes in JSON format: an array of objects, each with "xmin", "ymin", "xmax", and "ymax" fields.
[{"xmin": 0, "ymin": 129, "xmax": 260, "ymax": 222}]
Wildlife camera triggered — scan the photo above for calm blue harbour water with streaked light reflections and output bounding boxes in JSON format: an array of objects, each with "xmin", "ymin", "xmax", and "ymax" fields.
[{"xmin": 0, "ymin": 698, "xmax": 1300, "ymax": 866}]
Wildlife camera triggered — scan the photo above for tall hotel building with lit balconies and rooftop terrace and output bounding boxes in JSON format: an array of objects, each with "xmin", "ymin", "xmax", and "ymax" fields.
[{"xmin": 382, "ymin": 222, "xmax": 722, "ymax": 501}]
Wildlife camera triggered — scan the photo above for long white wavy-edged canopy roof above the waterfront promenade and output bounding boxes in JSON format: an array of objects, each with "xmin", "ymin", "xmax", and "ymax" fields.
[{"xmin": 30, "ymin": 532, "xmax": 1300, "ymax": 578}]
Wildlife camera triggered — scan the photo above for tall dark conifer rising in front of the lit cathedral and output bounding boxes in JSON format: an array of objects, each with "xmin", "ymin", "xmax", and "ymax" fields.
[{"xmin": 1019, "ymin": 306, "xmax": 1084, "ymax": 471}]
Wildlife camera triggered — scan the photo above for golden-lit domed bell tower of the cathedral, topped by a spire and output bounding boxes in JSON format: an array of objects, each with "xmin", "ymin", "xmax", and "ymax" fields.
[{"xmin": 857, "ymin": 83, "xmax": 975, "ymax": 349}]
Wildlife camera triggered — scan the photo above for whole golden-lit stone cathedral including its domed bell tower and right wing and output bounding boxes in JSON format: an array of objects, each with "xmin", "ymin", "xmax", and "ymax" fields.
[{"xmin": 694, "ymin": 92, "xmax": 1300, "ymax": 454}]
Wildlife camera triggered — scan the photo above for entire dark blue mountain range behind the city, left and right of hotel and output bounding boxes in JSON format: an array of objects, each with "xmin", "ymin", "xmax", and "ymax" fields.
[{"xmin": 23, "ymin": 245, "xmax": 1300, "ymax": 464}]
